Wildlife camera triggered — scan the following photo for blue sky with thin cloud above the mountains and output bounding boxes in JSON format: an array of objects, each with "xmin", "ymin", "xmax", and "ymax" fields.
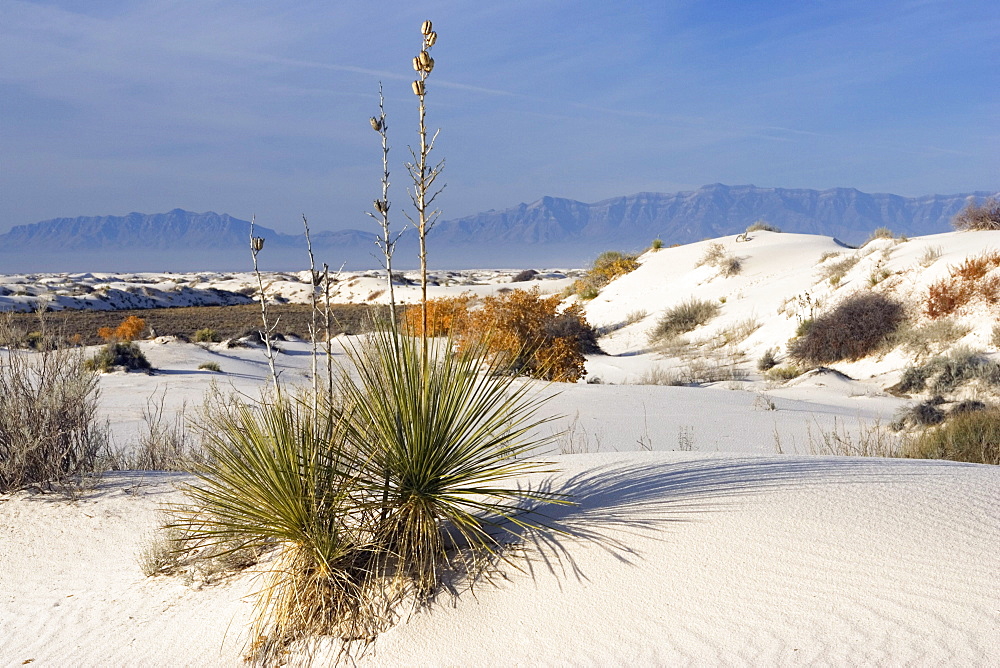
[{"xmin": 0, "ymin": 0, "xmax": 1000, "ymax": 232}]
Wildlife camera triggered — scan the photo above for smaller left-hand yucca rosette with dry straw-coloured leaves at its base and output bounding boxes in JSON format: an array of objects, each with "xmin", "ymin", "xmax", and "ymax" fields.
[{"xmin": 167, "ymin": 398, "xmax": 392, "ymax": 663}]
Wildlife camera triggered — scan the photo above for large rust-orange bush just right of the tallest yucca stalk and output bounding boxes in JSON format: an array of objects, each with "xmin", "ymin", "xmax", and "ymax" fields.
[{"xmin": 458, "ymin": 289, "xmax": 600, "ymax": 382}]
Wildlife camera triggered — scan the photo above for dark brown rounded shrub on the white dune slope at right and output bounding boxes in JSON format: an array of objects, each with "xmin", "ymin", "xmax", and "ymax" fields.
[{"xmin": 788, "ymin": 292, "xmax": 904, "ymax": 364}]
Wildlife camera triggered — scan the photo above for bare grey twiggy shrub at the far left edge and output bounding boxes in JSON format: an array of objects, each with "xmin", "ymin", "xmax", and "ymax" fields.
[{"xmin": 0, "ymin": 349, "xmax": 108, "ymax": 492}]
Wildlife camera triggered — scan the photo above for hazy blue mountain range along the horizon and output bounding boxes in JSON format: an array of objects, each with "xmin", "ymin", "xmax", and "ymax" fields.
[{"xmin": 0, "ymin": 184, "xmax": 996, "ymax": 273}]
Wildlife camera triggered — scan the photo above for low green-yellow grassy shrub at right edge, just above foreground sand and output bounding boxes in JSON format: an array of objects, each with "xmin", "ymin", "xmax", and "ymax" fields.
[{"xmin": 910, "ymin": 408, "xmax": 1000, "ymax": 465}]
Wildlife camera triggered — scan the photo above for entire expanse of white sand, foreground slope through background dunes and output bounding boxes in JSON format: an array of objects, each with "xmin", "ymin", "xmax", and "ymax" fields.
[{"xmin": 0, "ymin": 233, "xmax": 1000, "ymax": 666}]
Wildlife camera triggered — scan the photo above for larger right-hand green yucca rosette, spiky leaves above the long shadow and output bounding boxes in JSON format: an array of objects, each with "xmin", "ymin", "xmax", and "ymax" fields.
[{"xmin": 340, "ymin": 331, "xmax": 565, "ymax": 598}]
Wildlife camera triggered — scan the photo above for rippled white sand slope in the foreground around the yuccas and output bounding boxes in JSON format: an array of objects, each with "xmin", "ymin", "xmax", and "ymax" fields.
[{"xmin": 0, "ymin": 453, "xmax": 1000, "ymax": 666}]
